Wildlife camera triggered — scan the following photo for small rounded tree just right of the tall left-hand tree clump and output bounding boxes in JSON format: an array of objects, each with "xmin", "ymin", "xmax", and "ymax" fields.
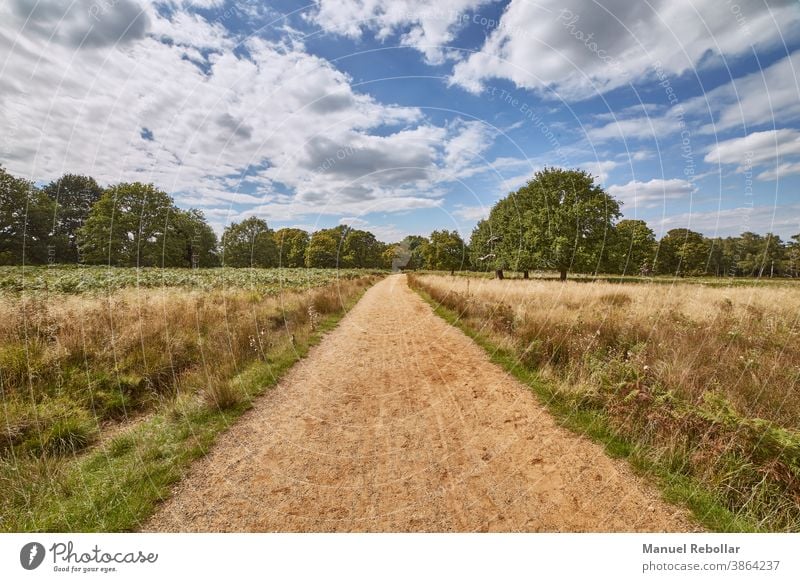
[{"xmin": 221, "ymin": 216, "xmax": 278, "ymax": 267}]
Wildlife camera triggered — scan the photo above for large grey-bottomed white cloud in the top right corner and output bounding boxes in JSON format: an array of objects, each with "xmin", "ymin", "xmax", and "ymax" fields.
[{"xmin": 451, "ymin": 0, "xmax": 800, "ymax": 100}]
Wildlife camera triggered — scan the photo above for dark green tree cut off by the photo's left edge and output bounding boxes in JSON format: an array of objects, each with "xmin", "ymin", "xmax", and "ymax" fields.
[{"xmin": 0, "ymin": 166, "xmax": 54, "ymax": 265}]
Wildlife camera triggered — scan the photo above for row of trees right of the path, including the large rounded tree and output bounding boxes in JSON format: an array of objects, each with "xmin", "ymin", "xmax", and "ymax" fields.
[{"xmin": 469, "ymin": 168, "xmax": 800, "ymax": 279}]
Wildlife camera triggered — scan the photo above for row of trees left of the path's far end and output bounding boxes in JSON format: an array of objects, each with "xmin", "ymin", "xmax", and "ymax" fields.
[{"xmin": 0, "ymin": 167, "xmax": 391, "ymax": 268}]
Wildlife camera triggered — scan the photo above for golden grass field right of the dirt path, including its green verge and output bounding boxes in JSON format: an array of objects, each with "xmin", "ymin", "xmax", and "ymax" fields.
[{"xmin": 411, "ymin": 274, "xmax": 800, "ymax": 531}]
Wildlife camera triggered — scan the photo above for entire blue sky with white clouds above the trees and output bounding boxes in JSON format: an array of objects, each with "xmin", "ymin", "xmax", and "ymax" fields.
[{"xmin": 0, "ymin": 0, "xmax": 800, "ymax": 242}]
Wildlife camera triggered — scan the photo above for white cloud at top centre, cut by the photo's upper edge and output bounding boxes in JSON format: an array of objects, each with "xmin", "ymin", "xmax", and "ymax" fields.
[{"xmin": 308, "ymin": 0, "xmax": 490, "ymax": 64}]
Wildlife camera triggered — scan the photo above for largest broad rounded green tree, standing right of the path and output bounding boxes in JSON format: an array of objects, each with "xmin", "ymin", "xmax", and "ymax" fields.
[{"xmin": 506, "ymin": 168, "xmax": 620, "ymax": 281}]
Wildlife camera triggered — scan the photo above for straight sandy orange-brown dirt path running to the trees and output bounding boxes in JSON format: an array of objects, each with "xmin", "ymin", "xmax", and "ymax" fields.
[{"xmin": 145, "ymin": 275, "xmax": 696, "ymax": 531}]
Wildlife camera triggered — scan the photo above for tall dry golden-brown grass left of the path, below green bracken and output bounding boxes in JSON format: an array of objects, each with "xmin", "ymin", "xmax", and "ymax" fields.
[{"xmin": 0, "ymin": 277, "xmax": 374, "ymax": 455}]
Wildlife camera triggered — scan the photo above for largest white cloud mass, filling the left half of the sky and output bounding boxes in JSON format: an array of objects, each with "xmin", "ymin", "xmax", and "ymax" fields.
[{"xmin": 0, "ymin": 0, "xmax": 494, "ymax": 226}]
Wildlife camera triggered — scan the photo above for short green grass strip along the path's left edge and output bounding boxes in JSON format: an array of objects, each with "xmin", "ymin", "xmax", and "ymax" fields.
[{"xmin": 0, "ymin": 291, "xmax": 363, "ymax": 532}]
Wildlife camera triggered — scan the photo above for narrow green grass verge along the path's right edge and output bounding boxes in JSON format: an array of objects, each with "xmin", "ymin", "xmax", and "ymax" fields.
[{"xmin": 414, "ymin": 288, "xmax": 756, "ymax": 532}]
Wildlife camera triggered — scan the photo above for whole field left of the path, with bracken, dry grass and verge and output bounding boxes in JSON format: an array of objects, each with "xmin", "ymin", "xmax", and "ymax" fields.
[{"xmin": 0, "ymin": 267, "xmax": 377, "ymax": 531}]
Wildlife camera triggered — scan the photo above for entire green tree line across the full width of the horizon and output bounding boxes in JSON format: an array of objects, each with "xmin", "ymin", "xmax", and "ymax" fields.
[{"xmin": 0, "ymin": 166, "xmax": 800, "ymax": 279}]
